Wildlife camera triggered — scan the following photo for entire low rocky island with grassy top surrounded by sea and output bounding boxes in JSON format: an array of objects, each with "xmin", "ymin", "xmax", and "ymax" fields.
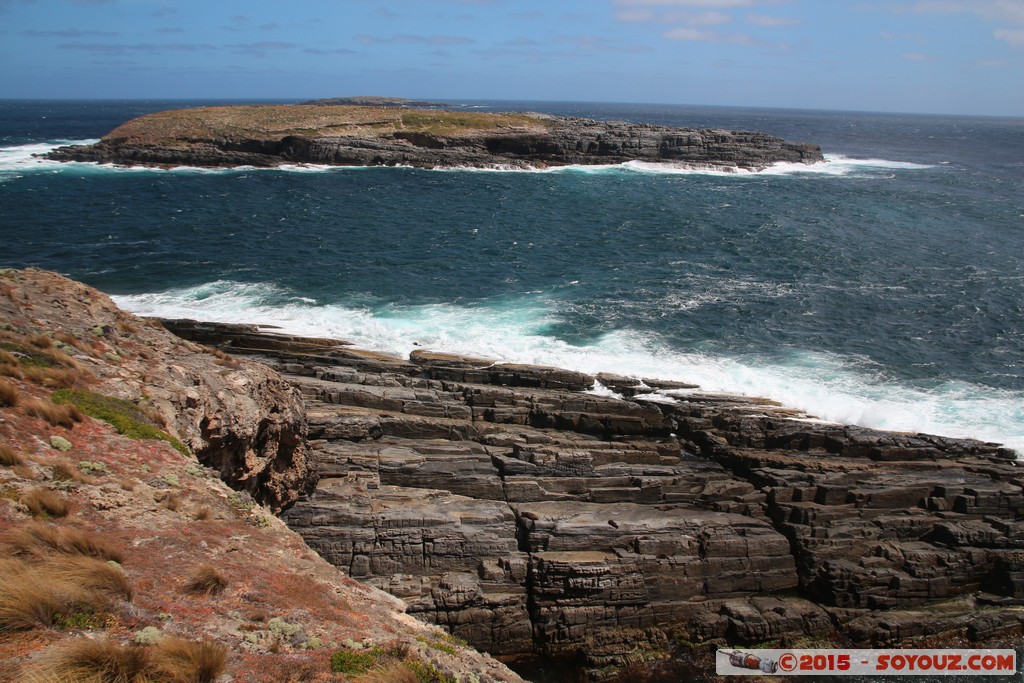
[{"xmin": 46, "ymin": 104, "xmax": 823, "ymax": 170}]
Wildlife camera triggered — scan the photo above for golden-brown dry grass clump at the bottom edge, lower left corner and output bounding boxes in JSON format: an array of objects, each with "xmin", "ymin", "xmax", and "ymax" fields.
[{"xmin": 22, "ymin": 638, "xmax": 227, "ymax": 683}]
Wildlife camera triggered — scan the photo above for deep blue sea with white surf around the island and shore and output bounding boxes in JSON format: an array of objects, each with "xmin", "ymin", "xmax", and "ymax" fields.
[{"xmin": 0, "ymin": 100, "xmax": 1024, "ymax": 453}]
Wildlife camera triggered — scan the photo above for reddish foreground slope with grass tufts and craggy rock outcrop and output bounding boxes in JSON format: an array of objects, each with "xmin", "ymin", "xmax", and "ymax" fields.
[{"xmin": 0, "ymin": 269, "xmax": 522, "ymax": 683}]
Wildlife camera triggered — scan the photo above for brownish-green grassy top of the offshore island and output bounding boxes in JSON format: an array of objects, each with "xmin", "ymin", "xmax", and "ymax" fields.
[{"xmin": 103, "ymin": 104, "xmax": 550, "ymax": 144}]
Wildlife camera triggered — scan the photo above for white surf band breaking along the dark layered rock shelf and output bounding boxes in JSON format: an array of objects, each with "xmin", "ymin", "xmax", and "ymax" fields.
[{"xmin": 115, "ymin": 281, "xmax": 1024, "ymax": 453}]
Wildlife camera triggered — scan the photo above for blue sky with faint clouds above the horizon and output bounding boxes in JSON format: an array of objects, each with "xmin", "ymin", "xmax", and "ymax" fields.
[{"xmin": 0, "ymin": 0, "xmax": 1024, "ymax": 116}]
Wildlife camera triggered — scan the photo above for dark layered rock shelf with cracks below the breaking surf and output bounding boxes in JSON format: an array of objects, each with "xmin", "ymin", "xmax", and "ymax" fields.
[{"xmin": 159, "ymin": 322, "xmax": 1024, "ymax": 672}]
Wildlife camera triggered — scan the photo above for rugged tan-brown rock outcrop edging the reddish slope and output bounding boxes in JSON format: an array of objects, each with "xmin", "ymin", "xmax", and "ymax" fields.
[{"xmin": 0, "ymin": 269, "xmax": 315, "ymax": 511}]
